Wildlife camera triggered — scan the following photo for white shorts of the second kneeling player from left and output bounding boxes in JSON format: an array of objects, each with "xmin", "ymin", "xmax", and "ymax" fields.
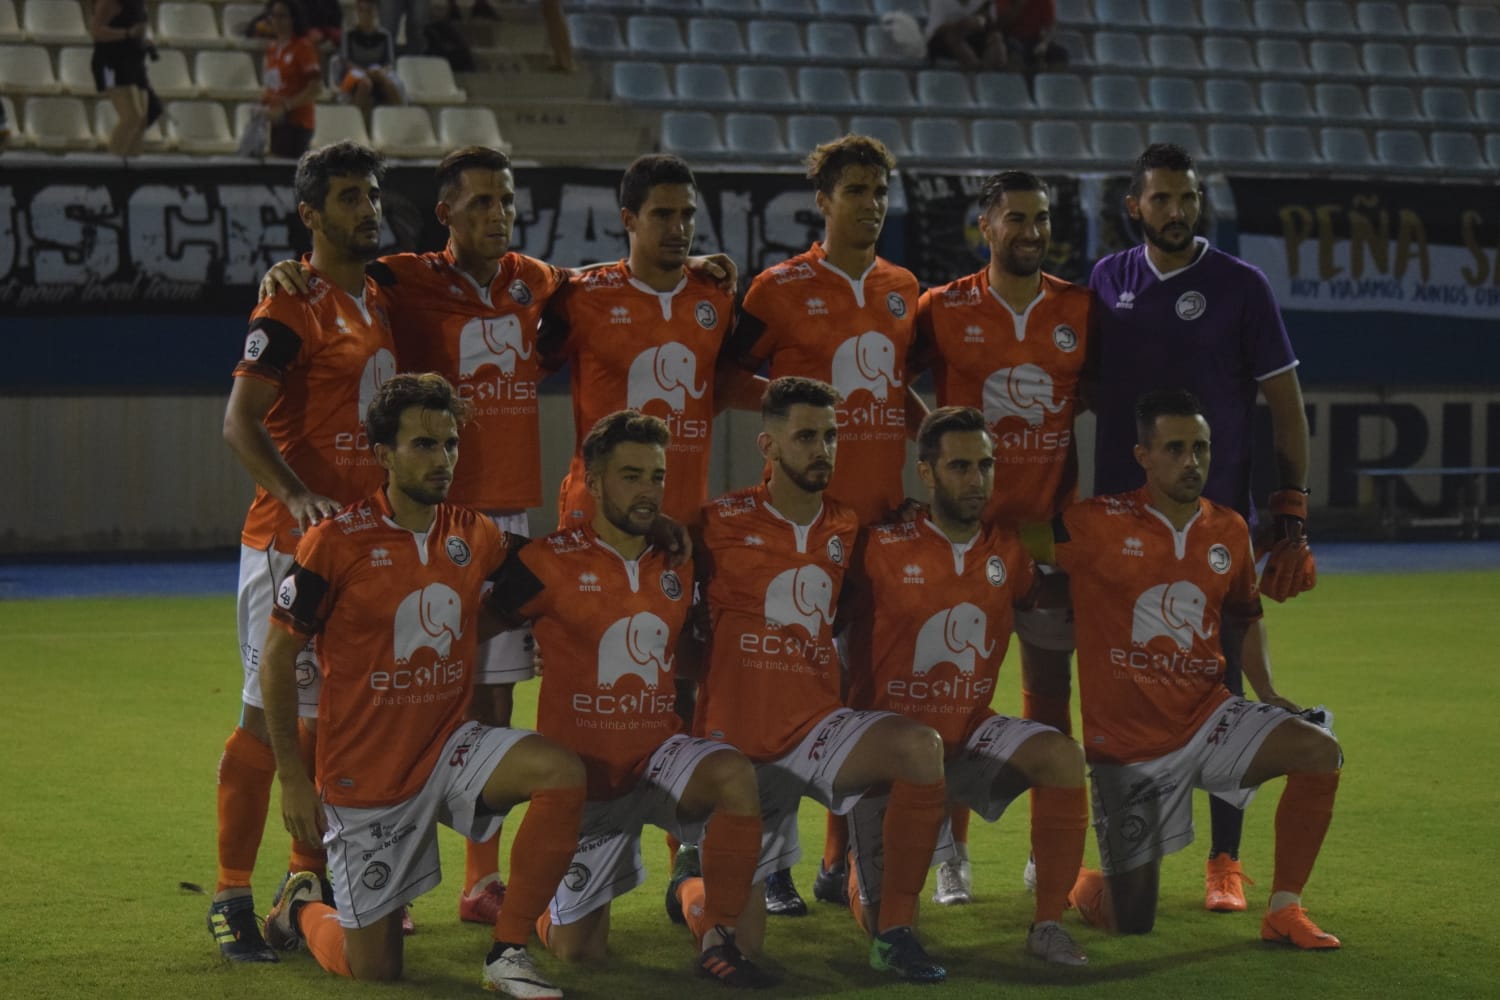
[{"xmin": 552, "ymin": 736, "xmax": 734, "ymax": 927}]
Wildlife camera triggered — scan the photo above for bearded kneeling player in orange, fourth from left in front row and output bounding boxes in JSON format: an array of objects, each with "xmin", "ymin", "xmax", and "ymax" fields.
[{"xmin": 846, "ymin": 406, "xmax": 1089, "ymax": 966}]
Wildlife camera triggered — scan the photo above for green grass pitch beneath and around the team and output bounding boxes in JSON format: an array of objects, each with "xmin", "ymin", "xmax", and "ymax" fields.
[{"xmin": 0, "ymin": 573, "xmax": 1500, "ymax": 1000}]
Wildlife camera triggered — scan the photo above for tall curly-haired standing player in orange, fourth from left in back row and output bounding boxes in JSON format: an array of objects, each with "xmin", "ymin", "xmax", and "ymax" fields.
[{"xmin": 728, "ymin": 135, "xmax": 927, "ymax": 916}]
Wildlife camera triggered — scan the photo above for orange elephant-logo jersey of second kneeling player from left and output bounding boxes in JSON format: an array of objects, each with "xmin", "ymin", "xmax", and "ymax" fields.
[{"xmin": 491, "ymin": 526, "xmax": 693, "ymax": 799}]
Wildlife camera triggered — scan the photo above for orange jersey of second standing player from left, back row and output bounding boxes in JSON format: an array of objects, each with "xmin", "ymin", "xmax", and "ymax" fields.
[{"xmin": 371, "ymin": 250, "xmax": 567, "ymax": 511}]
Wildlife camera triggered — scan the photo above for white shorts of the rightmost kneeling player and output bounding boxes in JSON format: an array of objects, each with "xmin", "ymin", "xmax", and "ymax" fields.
[{"xmin": 1089, "ymin": 696, "xmax": 1296, "ymax": 876}]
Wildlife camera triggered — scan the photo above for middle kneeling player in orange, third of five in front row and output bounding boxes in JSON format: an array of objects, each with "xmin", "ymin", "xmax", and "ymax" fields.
[{"xmin": 695, "ymin": 376, "xmax": 947, "ymax": 982}]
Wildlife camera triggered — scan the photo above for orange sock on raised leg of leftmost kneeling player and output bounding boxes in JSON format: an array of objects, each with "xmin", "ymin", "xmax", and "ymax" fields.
[{"xmin": 495, "ymin": 787, "xmax": 584, "ymax": 945}]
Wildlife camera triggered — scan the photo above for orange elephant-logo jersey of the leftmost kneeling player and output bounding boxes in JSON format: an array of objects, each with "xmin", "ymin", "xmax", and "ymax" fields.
[{"xmin": 272, "ymin": 490, "xmax": 510, "ymax": 808}]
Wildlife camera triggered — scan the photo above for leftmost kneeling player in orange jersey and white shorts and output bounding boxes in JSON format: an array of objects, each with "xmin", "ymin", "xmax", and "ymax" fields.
[{"xmin": 263, "ymin": 372, "xmax": 585, "ymax": 997}]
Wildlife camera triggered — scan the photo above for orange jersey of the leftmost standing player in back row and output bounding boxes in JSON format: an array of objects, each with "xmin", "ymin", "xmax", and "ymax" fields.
[{"xmin": 234, "ymin": 271, "xmax": 396, "ymax": 552}]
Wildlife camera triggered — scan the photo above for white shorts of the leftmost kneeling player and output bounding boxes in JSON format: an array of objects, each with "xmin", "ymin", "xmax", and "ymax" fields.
[{"xmin": 323, "ymin": 723, "xmax": 536, "ymax": 928}]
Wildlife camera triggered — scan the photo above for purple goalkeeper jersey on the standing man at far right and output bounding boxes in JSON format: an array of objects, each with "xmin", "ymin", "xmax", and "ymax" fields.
[{"xmin": 1089, "ymin": 237, "xmax": 1298, "ymax": 523}]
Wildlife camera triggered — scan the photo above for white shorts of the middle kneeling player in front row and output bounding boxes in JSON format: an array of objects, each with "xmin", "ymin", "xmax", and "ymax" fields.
[{"xmin": 755, "ymin": 708, "xmax": 894, "ymax": 882}]
